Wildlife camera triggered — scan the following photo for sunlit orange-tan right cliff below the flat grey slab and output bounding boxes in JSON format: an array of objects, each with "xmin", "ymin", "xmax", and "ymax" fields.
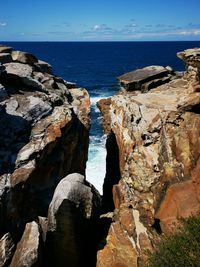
[{"xmin": 97, "ymin": 51, "xmax": 200, "ymax": 267}]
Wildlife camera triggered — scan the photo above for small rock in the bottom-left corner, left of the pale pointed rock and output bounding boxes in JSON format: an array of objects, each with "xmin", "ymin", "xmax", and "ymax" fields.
[{"xmin": 0, "ymin": 233, "xmax": 15, "ymax": 267}]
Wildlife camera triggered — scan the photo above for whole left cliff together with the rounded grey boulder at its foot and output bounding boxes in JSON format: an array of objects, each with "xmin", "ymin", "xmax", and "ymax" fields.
[{"xmin": 0, "ymin": 46, "xmax": 100, "ymax": 267}]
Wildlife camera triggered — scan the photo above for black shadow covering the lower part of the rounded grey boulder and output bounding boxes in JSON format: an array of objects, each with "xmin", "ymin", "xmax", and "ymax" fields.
[{"xmin": 45, "ymin": 199, "xmax": 97, "ymax": 267}]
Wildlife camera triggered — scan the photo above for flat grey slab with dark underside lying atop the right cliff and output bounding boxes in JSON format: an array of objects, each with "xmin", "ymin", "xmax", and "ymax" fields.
[{"xmin": 118, "ymin": 66, "xmax": 172, "ymax": 92}]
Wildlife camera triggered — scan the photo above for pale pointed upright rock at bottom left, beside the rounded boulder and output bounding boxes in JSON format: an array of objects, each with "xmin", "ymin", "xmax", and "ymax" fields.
[{"xmin": 10, "ymin": 222, "xmax": 42, "ymax": 267}]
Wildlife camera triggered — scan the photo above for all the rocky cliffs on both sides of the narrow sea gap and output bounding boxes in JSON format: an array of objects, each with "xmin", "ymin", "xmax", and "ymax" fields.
[{"xmin": 0, "ymin": 46, "xmax": 200, "ymax": 267}]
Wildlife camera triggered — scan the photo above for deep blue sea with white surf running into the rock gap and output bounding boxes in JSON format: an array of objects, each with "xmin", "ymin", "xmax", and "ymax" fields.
[{"xmin": 6, "ymin": 41, "xmax": 200, "ymax": 193}]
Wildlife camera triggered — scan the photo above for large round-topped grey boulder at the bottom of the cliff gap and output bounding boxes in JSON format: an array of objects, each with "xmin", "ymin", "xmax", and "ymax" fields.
[{"xmin": 46, "ymin": 173, "xmax": 100, "ymax": 266}]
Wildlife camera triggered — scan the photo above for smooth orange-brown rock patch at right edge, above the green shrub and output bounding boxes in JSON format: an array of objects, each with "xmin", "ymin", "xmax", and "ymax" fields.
[{"xmin": 156, "ymin": 159, "xmax": 200, "ymax": 232}]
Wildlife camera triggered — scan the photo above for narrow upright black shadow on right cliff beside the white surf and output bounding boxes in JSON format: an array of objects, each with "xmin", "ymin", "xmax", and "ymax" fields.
[{"xmin": 102, "ymin": 132, "xmax": 120, "ymax": 213}]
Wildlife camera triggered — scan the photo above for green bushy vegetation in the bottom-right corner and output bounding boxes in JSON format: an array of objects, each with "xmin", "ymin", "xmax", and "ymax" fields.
[{"xmin": 147, "ymin": 215, "xmax": 200, "ymax": 267}]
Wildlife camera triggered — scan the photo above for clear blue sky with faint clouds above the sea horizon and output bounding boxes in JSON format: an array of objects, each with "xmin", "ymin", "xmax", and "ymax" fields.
[{"xmin": 0, "ymin": 0, "xmax": 200, "ymax": 41}]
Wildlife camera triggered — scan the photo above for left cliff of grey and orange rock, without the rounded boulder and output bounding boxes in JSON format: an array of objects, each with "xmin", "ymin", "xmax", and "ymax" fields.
[{"xmin": 0, "ymin": 46, "xmax": 95, "ymax": 266}]
